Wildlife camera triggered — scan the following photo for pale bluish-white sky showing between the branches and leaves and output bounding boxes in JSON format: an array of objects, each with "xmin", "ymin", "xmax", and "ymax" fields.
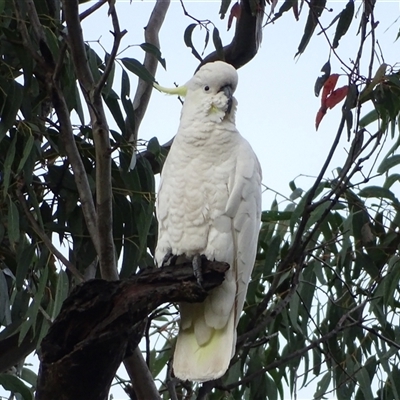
[{"xmin": 0, "ymin": 0, "xmax": 400, "ymax": 400}]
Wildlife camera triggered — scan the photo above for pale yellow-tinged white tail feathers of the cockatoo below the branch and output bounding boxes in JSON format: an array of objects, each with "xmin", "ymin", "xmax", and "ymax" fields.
[{"xmin": 174, "ymin": 308, "xmax": 236, "ymax": 382}]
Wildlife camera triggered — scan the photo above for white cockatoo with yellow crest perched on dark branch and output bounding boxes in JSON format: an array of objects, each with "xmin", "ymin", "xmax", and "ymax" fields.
[{"xmin": 155, "ymin": 61, "xmax": 261, "ymax": 382}]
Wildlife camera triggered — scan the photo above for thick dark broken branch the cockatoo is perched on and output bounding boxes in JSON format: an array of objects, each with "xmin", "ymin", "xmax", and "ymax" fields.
[{"xmin": 36, "ymin": 260, "xmax": 229, "ymax": 400}]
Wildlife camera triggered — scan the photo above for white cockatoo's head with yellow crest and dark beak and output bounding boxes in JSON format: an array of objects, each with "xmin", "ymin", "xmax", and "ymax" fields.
[{"xmin": 154, "ymin": 61, "xmax": 238, "ymax": 121}]
